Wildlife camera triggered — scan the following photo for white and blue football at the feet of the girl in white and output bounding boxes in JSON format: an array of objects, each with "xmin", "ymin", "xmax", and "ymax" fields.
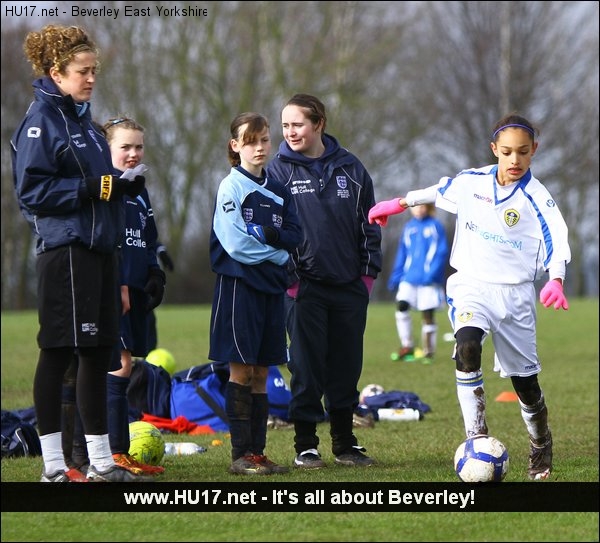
[{"xmin": 454, "ymin": 435, "xmax": 509, "ymax": 483}]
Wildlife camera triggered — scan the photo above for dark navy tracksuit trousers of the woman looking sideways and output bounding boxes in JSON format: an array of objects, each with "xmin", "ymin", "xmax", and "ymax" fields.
[{"xmin": 286, "ymin": 278, "xmax": 369, "ymax": 455}]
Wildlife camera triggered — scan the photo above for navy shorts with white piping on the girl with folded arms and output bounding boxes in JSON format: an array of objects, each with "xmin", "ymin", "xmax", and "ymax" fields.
[{"xmin": 208, "ymin": 275, "xmax": 287, "ymax": 366}]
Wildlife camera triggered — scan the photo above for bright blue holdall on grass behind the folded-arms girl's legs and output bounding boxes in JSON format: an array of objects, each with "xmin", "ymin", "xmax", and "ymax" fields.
[{"xmin": 171, "ymin": 362, "xmax": 291, "ymax": 432}]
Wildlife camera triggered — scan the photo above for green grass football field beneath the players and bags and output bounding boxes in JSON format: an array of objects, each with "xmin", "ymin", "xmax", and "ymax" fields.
[{"xmin": 1, "ymin": 299, "xmax": 599, "ymax": 541}]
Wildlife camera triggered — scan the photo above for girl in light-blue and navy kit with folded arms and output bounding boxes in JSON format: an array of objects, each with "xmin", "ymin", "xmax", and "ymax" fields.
[{"xmin": 208, "ymin": 113, "xmax": 302, "ymax": 475}]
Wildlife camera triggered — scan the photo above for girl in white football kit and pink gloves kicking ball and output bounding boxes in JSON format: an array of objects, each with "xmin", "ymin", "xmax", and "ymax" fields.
[{"xmin": 369, "ymin": 115, "xmax": 571, "ymax": 480}]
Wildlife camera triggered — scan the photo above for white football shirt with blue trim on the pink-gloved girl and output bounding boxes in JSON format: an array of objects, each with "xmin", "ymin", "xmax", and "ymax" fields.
[{"xmin": 426, "ymin": 164, "xmax": 571, "ymax": 284}]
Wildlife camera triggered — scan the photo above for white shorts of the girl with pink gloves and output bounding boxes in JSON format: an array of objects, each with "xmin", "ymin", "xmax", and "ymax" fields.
[{"xmin": 446, "ymin": 273, "xmax": 541, "ymax": 377}]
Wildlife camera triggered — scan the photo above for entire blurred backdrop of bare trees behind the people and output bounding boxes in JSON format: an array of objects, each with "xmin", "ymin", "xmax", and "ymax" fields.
[{"xmin": 1, "ymin": 1, "xmax": 598, "ymax": 308}]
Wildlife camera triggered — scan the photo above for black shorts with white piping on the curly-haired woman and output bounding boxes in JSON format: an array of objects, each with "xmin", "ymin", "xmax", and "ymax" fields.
[{"xmin": 36, "ymin": 245, "xmax": 121, "ymax": 349}]
